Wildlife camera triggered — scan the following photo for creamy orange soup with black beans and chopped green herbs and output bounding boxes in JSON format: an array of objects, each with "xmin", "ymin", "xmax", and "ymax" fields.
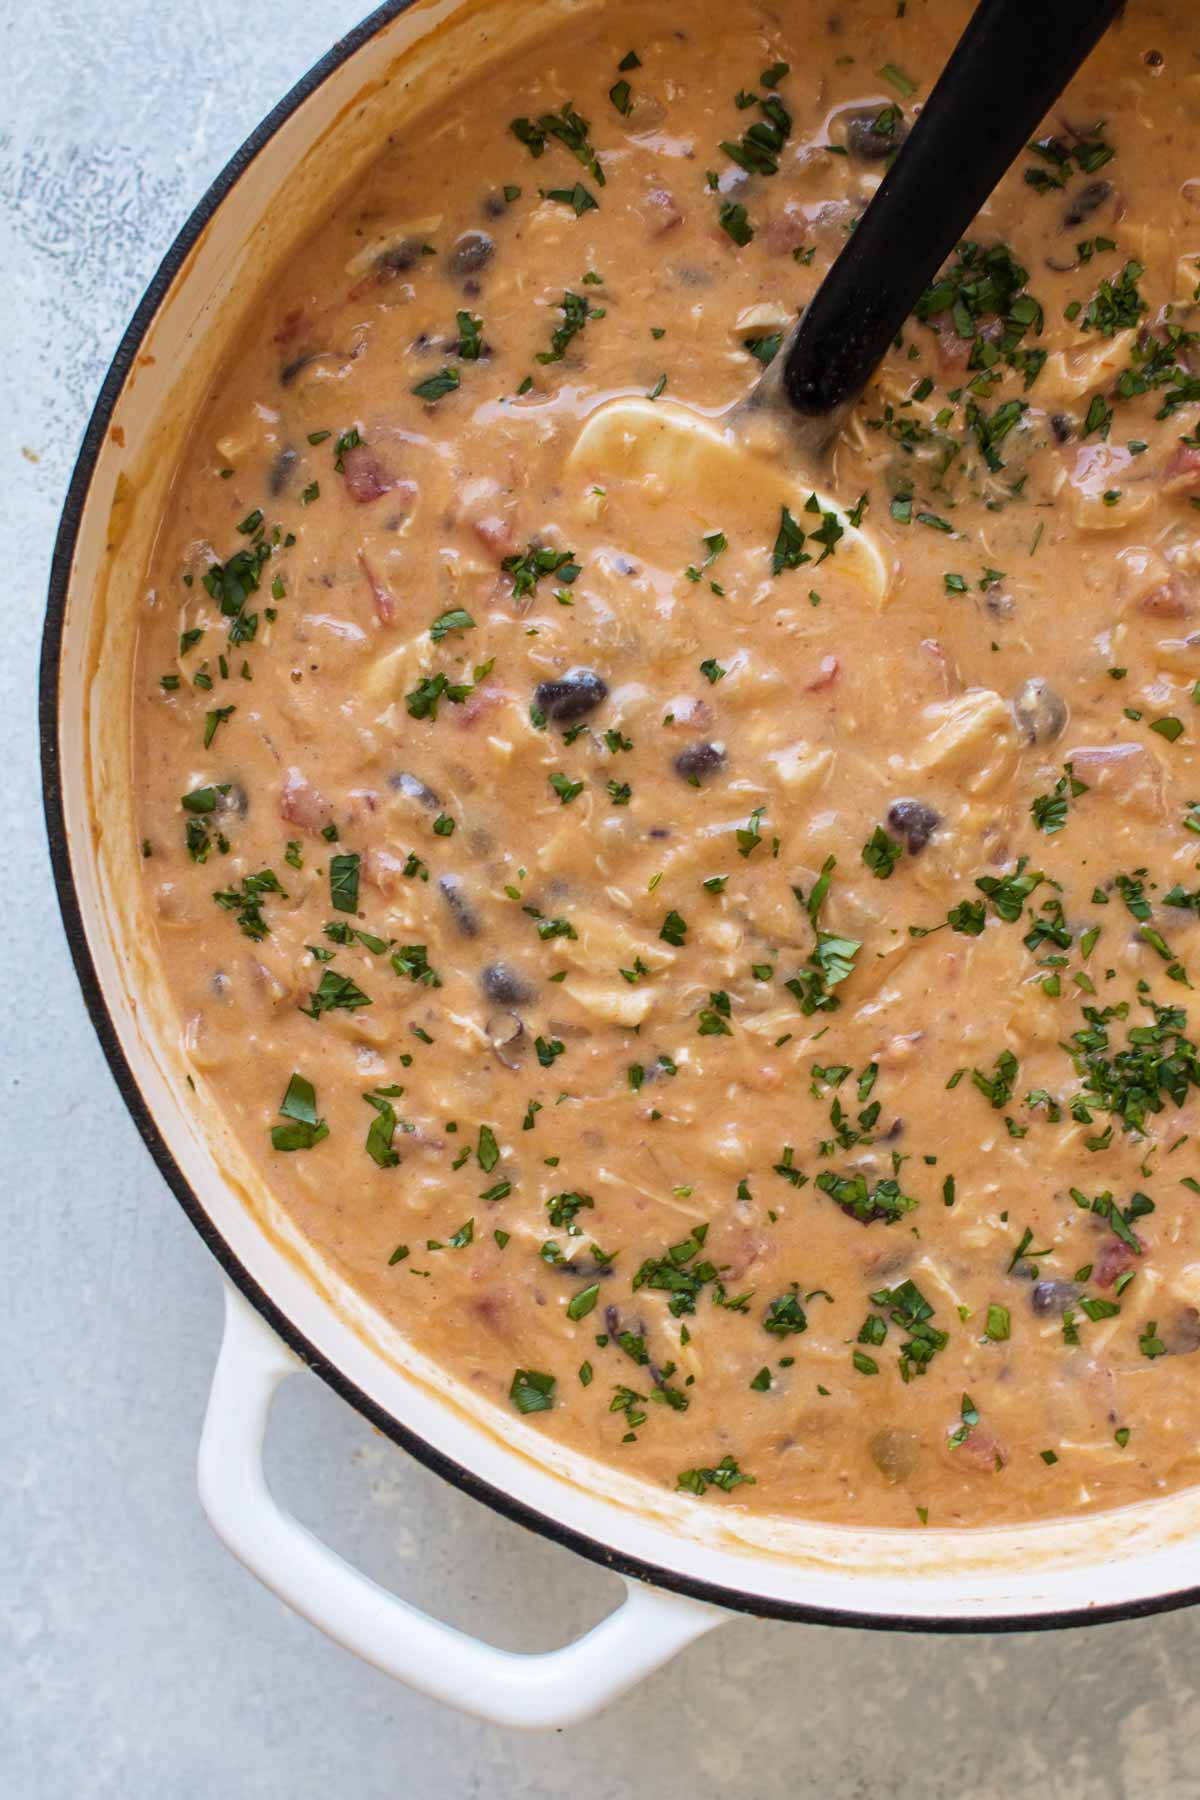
[{"xmin": 135, "ymin": 0, "xmax": 1200, "ymax": 1526}]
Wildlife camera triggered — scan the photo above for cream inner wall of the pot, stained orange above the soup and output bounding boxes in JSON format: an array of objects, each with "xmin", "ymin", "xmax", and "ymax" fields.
[{"xmin": 50, "ymin": 0, "xmax": 1200, "ymax": 1620}]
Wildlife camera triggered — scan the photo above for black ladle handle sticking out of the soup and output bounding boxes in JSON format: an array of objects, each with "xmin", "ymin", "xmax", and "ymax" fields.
[{"xmin": 783, "ymin": 0, "xmax": 1124, "ymax": 418}]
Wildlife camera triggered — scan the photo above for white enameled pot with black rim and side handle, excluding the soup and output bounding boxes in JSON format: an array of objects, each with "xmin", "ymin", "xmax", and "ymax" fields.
[{"xmin": 41, "ymin": 0, "xmax": 1200, "ymax": 1726}]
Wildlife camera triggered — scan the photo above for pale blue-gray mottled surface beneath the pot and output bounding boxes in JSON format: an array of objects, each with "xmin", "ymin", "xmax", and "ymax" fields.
[{"xmin": 0, "ymin": 0, "xmax": 1200, "ymax": 1800}]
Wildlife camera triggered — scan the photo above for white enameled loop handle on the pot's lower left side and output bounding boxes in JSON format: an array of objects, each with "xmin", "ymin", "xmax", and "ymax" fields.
[{"xmin": 198, "ymin": 1282, "xmax": 729, "ymax": 1730}]
